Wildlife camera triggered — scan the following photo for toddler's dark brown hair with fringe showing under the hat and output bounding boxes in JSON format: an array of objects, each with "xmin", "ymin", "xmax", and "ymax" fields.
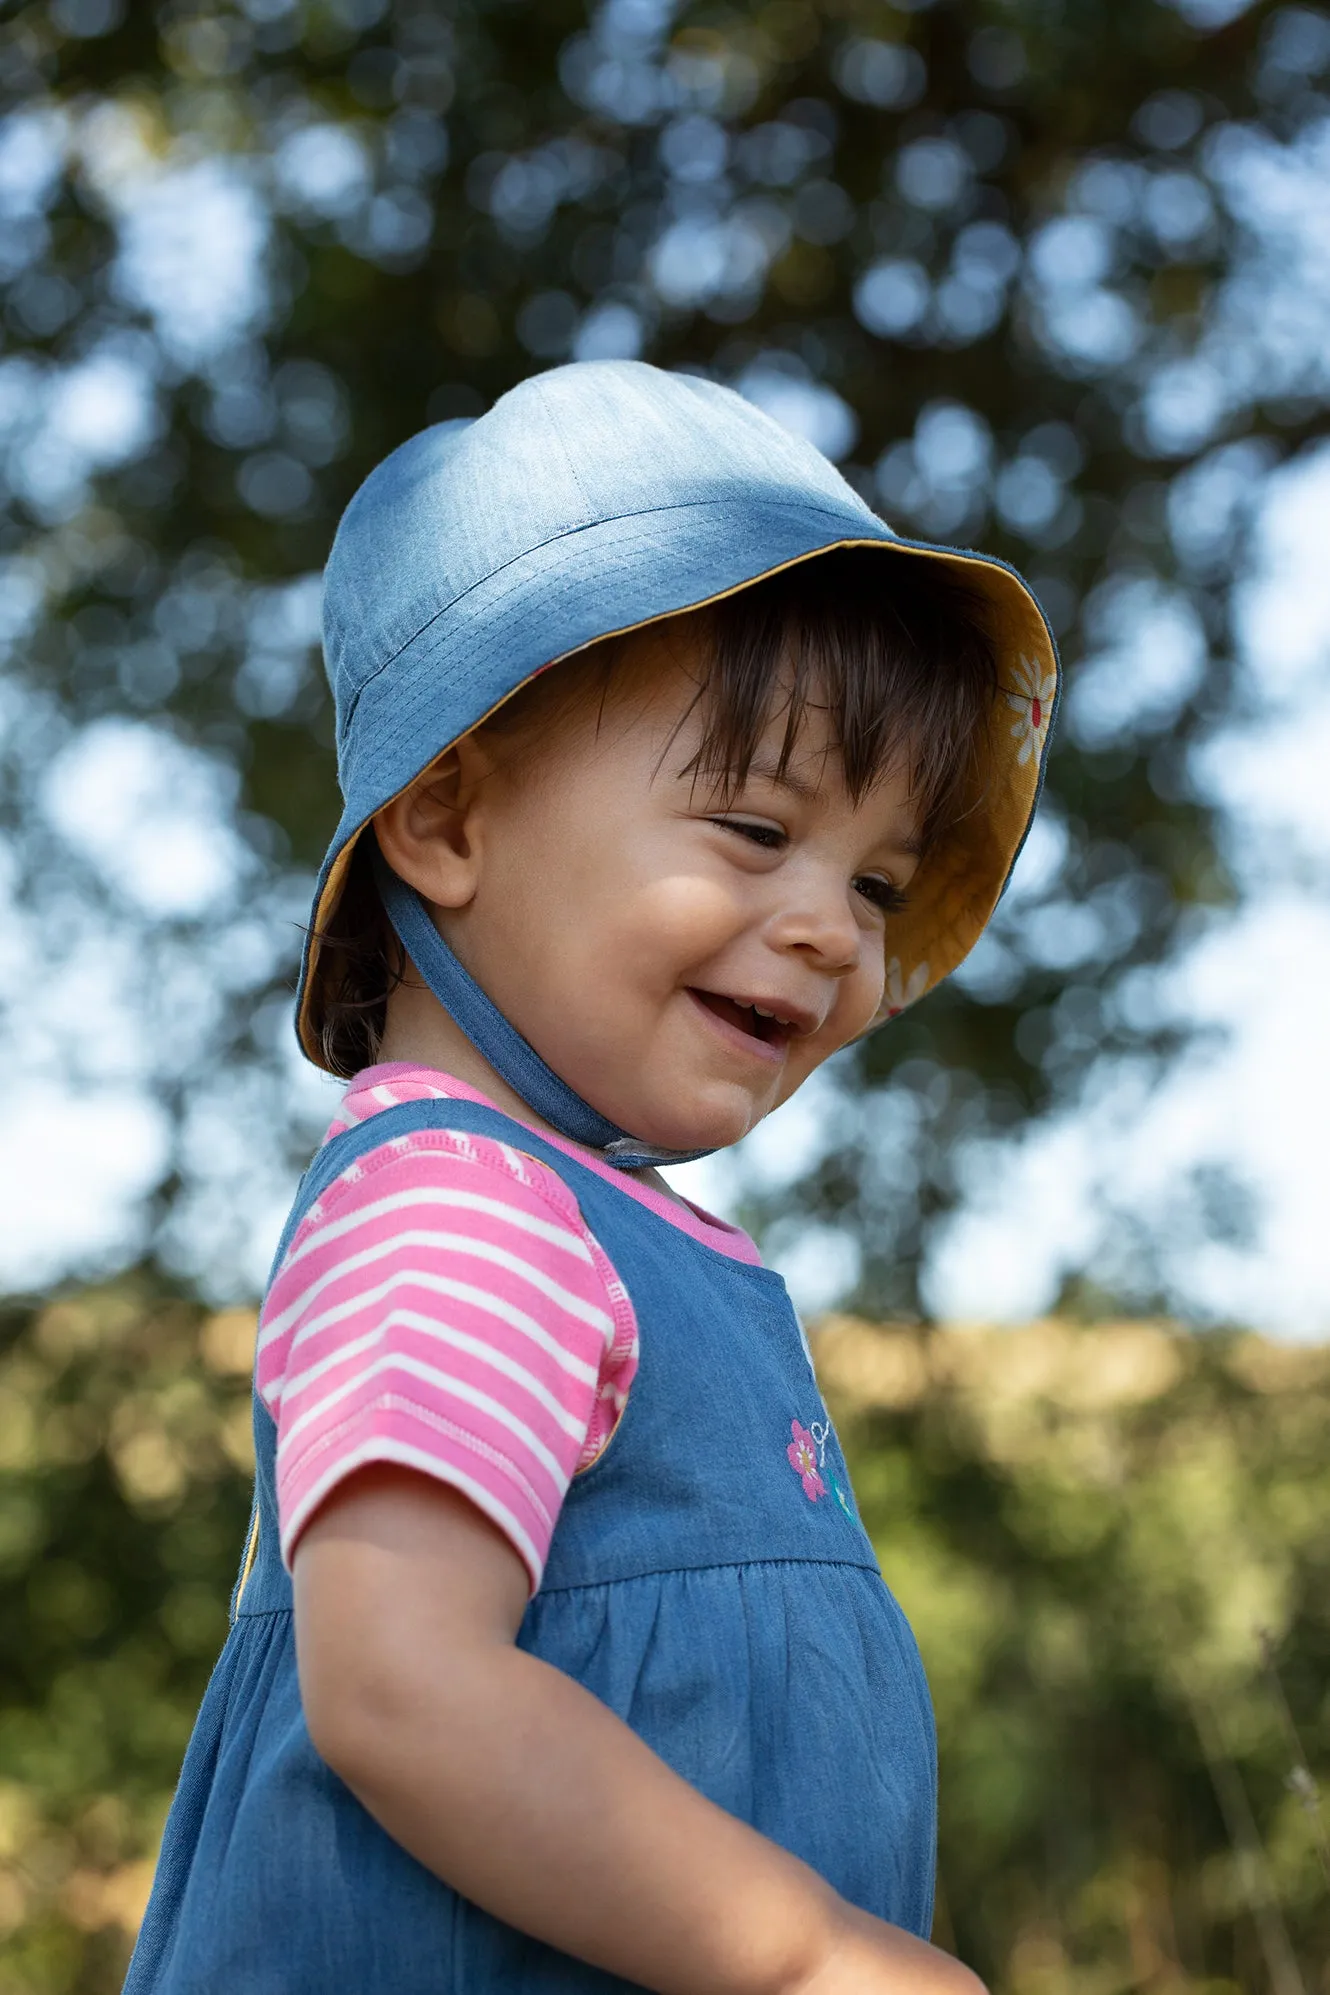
[{"xmin": 315, "ymin": 549, "xmax": 997, "ymax": 1077}]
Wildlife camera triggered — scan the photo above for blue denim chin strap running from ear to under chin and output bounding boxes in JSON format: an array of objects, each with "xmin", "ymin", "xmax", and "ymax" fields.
[{"xmin": 373, "ymin": 848, "xmax": 714, "ymax": 1171}]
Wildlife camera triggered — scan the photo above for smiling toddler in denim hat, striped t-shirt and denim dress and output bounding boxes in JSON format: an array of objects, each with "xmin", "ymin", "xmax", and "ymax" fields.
[{"xmin": 128, "ymin": 361, "xmax": 1057, "ymax": 1995}]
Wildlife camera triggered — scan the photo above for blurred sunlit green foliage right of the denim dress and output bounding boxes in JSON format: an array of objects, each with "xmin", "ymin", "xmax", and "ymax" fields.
[{"xmin": 818, "ymin": 1319, "xmax": 1330, "ymax": 1995}]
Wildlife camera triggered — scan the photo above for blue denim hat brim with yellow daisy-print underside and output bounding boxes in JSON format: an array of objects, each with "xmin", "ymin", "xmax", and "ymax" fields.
[{"xmin": 297, "ymin": 501, "xmax": 1061, "ymax": 1067}]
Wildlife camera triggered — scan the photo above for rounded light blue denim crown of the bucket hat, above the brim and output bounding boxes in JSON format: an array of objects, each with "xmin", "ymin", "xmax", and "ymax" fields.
[{"xmin": 323, "ymin": 361, "xmax": 883, "ymax": 740}]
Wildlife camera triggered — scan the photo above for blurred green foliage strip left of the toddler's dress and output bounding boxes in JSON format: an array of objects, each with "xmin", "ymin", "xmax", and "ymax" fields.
[{"xmin": 0, "ymin": 1279, "xmax": 253, "ymax": 1995}]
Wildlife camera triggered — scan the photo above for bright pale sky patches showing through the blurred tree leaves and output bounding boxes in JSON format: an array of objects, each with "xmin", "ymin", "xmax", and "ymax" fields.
[{"xmin": 0, "ymin": 31, "xmax": 1330, "ymax": 1339}]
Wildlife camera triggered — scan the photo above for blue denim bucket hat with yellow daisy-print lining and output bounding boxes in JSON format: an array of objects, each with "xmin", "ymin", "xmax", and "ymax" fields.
[{"xmin": 295, "ymin": 361, "xmax": 1059, "ymax": 1065}]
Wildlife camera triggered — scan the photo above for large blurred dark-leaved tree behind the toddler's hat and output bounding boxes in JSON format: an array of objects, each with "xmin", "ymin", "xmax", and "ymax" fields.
[{"xmin": 0, "ymin": 0, "xmax": 1330, "ymax": 1309}]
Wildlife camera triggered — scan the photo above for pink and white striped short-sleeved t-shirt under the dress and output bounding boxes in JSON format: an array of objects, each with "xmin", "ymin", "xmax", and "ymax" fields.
[{"xmin": 257, "ymin": 1061, "xmax": 758, "ymax": 1592}]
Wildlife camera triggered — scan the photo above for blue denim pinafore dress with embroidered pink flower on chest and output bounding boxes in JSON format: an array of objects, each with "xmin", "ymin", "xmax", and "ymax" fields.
[{"xmin": 126, "ymin": 1099, "xmax": 935, "ymax": 1995}]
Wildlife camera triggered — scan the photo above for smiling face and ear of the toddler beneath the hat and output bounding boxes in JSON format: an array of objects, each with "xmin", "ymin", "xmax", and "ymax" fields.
[{"xmin": 385, "ymin": 632, "xmax": 919, "ymax": 1149}]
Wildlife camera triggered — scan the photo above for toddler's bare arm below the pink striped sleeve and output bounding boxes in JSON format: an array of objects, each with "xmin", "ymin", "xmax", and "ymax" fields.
[{"xmin": 295, "ymin": 1466, "xmax": 983, "ymax": 1995}]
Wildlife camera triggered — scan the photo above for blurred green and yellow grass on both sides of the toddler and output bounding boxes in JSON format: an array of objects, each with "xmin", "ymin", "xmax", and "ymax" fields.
[{"xmin": 0, "ymin": 1277, "xmax": 1330, "ymax": 1995}]
